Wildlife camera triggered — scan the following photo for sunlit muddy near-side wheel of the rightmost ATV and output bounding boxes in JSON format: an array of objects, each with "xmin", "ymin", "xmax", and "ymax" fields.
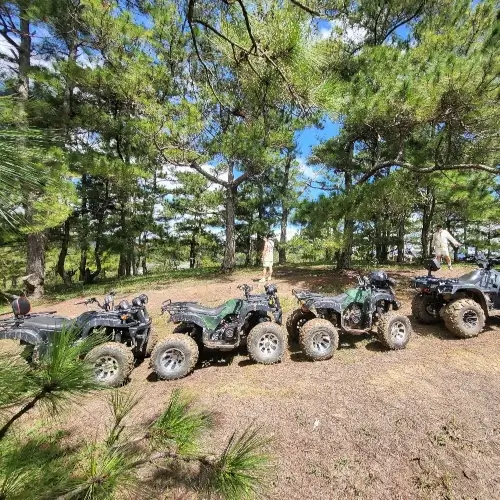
[{"xmin": 443, "ymin": 299, "xmax": 486, "ymax": 339}]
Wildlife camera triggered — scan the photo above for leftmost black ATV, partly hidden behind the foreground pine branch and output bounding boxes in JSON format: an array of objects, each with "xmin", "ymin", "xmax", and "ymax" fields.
[{"xmin": 0, "ymin": 292, "xmax": 158, "ymax": 387}]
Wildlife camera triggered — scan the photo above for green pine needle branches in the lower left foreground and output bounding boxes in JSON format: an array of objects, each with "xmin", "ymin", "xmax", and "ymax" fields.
[{"xmin": 0, "ymin": 332, "xmax": 270, "ymax": 500}]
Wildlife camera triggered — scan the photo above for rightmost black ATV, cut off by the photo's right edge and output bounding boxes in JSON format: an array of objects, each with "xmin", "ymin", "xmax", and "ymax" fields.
[{"xmin": 411, "ymin": 259, "xmax": 500, "ymax": 338}]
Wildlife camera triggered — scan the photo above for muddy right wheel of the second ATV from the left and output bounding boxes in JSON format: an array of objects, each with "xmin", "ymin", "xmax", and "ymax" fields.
[{"xmin": 247, "ymin": 321, "xmax": 286, "ymax": 365}]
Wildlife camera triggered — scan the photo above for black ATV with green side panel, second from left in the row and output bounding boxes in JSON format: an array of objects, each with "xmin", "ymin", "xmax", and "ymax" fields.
[{"xmin": 151, "ymin": 284, "xmax": 286, "ymax": 380}]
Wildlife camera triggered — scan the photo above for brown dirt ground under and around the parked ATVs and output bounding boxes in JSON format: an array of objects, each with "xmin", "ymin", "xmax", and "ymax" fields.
[{"xmin": 0, "ymin": 267, "xmax": 500, "ymax": 500}]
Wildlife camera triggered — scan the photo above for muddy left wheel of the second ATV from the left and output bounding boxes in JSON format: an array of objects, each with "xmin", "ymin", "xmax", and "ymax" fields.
[{"xmin": 150, "ymin": 333, "xmax": 199, "ymax": 380}]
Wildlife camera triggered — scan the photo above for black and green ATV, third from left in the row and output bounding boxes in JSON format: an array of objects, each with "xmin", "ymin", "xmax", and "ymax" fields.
[{"xmin": 286, "ymin": 271, "xmax": 412, "ymax": 361}]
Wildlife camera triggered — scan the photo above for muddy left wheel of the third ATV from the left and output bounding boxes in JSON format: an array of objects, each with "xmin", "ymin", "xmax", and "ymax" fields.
[{"xmin": 299, "ymin": 318, "xmax": 339, "ymax": 361}]
